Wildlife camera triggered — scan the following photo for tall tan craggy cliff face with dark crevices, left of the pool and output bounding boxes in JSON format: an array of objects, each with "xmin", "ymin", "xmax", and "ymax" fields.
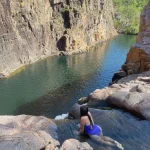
[{"xmin": 0, "ymin": 0, "xmax": 116, "ymax": 78}]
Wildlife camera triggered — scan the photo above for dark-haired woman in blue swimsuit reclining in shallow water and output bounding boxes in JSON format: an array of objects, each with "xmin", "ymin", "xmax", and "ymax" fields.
[{"xmin": 80, "ymin": 105, "xmax": 123, "ymax": 150}]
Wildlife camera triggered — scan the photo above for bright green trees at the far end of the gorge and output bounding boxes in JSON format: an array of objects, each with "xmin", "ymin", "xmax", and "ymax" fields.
[{"xmin": 113, "ymin": 0, "xmax": 149, "ymax": 34}]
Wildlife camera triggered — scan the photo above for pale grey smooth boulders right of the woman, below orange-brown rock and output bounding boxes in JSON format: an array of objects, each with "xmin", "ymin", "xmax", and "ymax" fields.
[{"xmin": 88, "ymin": 71, "xmax": 150, "ymax": 120}]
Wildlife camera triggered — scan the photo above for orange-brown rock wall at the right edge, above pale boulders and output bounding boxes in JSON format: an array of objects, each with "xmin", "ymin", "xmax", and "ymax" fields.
[{"xmin": 113, "ymin": 2, "xmax": 150, "ymax": 81}]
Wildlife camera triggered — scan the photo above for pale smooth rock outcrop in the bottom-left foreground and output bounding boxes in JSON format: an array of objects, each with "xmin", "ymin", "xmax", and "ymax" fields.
[{"xmin": 0, "ymin": 115, "xmax": 93, "ymax": 150}]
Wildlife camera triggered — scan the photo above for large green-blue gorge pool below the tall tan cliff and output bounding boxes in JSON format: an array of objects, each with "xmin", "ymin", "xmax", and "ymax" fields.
[{"xmin": 0, "ymin": 35, "xmax": 135, "ymax": 118}]
